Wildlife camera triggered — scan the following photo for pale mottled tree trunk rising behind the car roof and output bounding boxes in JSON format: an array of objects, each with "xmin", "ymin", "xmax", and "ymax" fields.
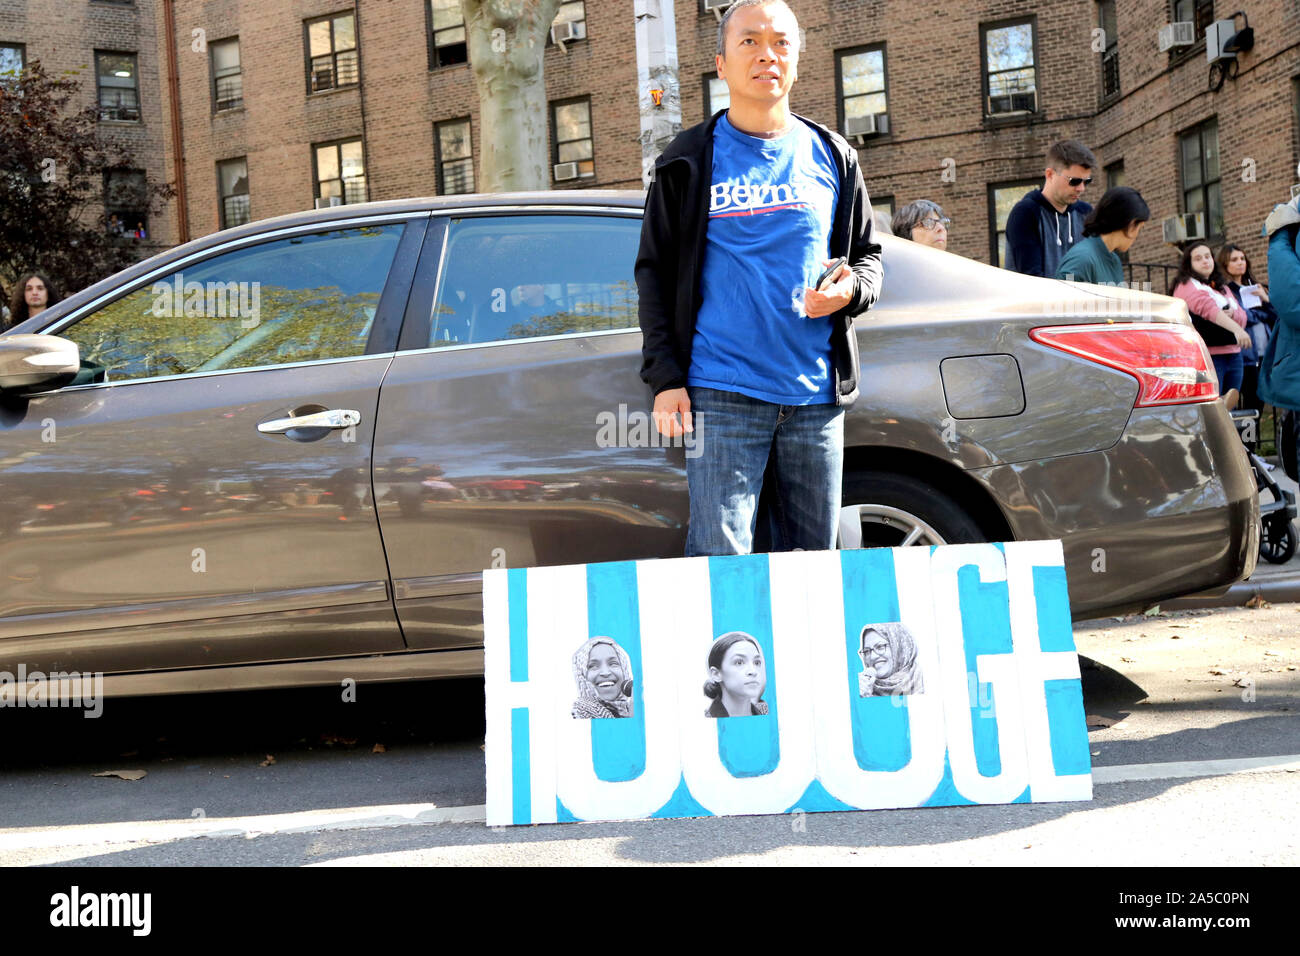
[{"xmin": 460, "ymin": 0, "xmax": 559, "ymax": 193}]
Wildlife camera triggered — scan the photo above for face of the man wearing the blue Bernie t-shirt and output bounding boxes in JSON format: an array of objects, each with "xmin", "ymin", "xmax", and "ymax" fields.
[{"xmin": 718, "ymin": 4, "xmax": 800, "ymax": 104}]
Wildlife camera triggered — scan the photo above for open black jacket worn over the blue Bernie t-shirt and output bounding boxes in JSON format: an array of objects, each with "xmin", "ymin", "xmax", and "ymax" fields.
[{"xmin": 636, "ymin": 111, "xmax": 883, "ymax": 405}]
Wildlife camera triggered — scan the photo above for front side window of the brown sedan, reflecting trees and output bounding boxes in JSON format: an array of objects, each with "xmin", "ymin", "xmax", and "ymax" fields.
[{"xmin": 59, "ymin": 224, "xmax": 404, "ymax": 382}]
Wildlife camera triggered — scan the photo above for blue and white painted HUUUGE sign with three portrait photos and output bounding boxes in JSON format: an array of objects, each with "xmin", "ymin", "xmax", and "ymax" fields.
[{"xmin": 484, "ymin": 541, "xmax": 1092, "ymax": 826}]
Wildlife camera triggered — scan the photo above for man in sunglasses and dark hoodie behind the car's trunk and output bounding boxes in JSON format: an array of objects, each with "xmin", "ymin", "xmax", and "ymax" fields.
[{"xmin": 1006, "ymin": 139, "xmax": 1097, "ymax": 276}]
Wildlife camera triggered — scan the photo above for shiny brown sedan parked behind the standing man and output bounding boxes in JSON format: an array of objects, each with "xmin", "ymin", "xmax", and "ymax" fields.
[{"xmin": 0, "ymin": 191, "xmax": 1258, "ymax": 693}]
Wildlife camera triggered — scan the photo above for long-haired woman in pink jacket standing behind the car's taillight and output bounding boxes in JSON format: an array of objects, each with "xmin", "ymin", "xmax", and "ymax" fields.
[{"xmin": 1169, "ymin": 242, "xmax": 1251, "ymax": 411}]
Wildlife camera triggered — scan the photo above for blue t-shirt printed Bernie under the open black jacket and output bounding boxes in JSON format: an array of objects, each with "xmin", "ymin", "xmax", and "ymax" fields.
[{"xmin": 686, "ymin": 113, "xmax": 840, "ymax": 405}]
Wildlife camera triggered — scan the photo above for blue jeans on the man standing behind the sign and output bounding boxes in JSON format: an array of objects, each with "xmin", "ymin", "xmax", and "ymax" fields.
[{"xmin": 686, "ymin": 386, "xmax": 844, "ymax": 557}]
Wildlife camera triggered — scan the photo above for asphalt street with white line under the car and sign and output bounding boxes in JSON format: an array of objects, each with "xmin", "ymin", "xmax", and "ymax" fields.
[{"xmin": 0, "ymin": 605, "xmax": 1300, "ymax": 866}]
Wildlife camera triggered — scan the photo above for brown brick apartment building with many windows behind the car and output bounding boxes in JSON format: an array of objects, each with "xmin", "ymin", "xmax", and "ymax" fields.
[{"xmin": 0, "ymin": 0, "xmax": 1300, "ymax": 287}]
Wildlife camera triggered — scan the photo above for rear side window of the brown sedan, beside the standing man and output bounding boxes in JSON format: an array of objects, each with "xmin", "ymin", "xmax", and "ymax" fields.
[{"xmin": 429, "ymin": 216, "xmax": 641, "ymax": 347}]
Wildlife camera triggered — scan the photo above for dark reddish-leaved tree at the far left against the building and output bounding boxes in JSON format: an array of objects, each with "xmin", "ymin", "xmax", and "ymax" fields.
[{"xmin": 0, "ymin": 61, "xmax": 176, "ymax": 303}]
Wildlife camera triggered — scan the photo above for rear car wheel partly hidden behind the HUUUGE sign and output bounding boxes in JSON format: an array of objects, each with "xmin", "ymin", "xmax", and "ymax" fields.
[{"xmin": 839, "ymin": 471, "xmax": 988, "ymax": 548}]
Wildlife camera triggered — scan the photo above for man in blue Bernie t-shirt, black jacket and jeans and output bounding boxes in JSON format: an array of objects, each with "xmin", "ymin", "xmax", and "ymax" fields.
[{"xmin": 636, "ymin": 0, "xmax": 881, "ymax": 555}]
